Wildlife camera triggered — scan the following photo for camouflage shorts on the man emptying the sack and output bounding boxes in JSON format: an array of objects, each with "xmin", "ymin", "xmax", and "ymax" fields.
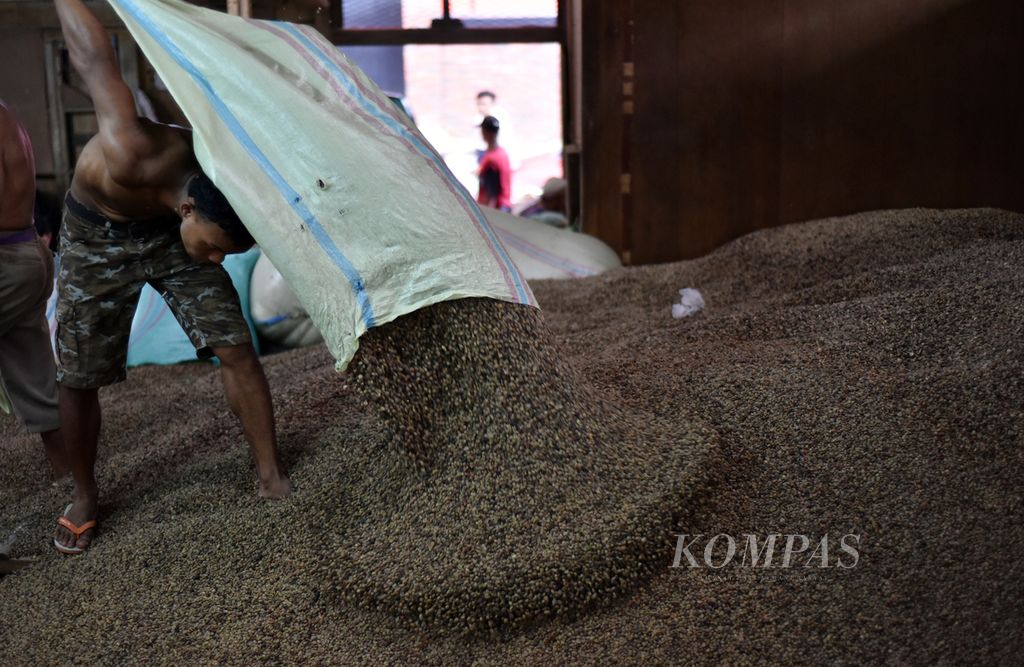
[{"xmin": 56, "ymin": 195, "xmax": 252, "ymax": 388}]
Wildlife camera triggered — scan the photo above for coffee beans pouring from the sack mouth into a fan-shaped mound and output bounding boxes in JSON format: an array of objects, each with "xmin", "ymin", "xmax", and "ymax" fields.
[{"xmin": 311, "ymin": 299, "xmax": 712, "ymax": 632}]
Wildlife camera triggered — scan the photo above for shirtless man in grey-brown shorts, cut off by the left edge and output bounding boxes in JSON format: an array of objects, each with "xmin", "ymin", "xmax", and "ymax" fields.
[{"xmin": 0, "ymin": 99, "xmax": 68, "ymax": 477}]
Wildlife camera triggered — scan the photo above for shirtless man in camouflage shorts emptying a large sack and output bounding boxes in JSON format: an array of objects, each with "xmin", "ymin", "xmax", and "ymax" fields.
[{"xmin": 53, "ymin": 0, "xmax": 291, "ymax": 553}]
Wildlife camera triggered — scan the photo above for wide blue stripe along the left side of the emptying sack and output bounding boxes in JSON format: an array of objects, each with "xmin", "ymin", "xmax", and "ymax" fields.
[{"xmin": 112, "ymin": 0, "xmax": 374, "ymax": 328}]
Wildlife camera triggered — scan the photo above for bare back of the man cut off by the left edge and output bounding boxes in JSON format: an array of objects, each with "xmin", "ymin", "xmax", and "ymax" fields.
[{"xmin": 0, "ymin": 99, "xmax": 36, "ymax": 232}]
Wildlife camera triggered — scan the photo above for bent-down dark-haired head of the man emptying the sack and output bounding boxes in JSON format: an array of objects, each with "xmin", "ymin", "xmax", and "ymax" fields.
[{"xmin": 178, "ymin": 172, "xmax": 255, "ymax": 264}]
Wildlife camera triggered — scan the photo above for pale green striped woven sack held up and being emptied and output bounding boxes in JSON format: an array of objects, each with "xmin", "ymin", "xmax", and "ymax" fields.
[{"xmin": 111, "ymin": 0, "xmax": 537, "ymax": 370}]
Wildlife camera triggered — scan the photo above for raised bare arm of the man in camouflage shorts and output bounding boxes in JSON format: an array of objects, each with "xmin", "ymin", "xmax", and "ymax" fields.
[{"xmin": 55, "ymin": 0, "xmax": 152, "ymax": 182}]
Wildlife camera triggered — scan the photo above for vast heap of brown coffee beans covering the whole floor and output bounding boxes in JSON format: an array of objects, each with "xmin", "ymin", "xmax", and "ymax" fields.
[{"xmin": 0, "ymin": 209, "xmax": 1024, "ymax": 666}]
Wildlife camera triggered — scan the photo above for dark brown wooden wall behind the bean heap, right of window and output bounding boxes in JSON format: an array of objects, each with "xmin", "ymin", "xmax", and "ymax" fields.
[{"xmin": 582, "ymin": 0, "xmax": 1024, "ymax": 263}]
